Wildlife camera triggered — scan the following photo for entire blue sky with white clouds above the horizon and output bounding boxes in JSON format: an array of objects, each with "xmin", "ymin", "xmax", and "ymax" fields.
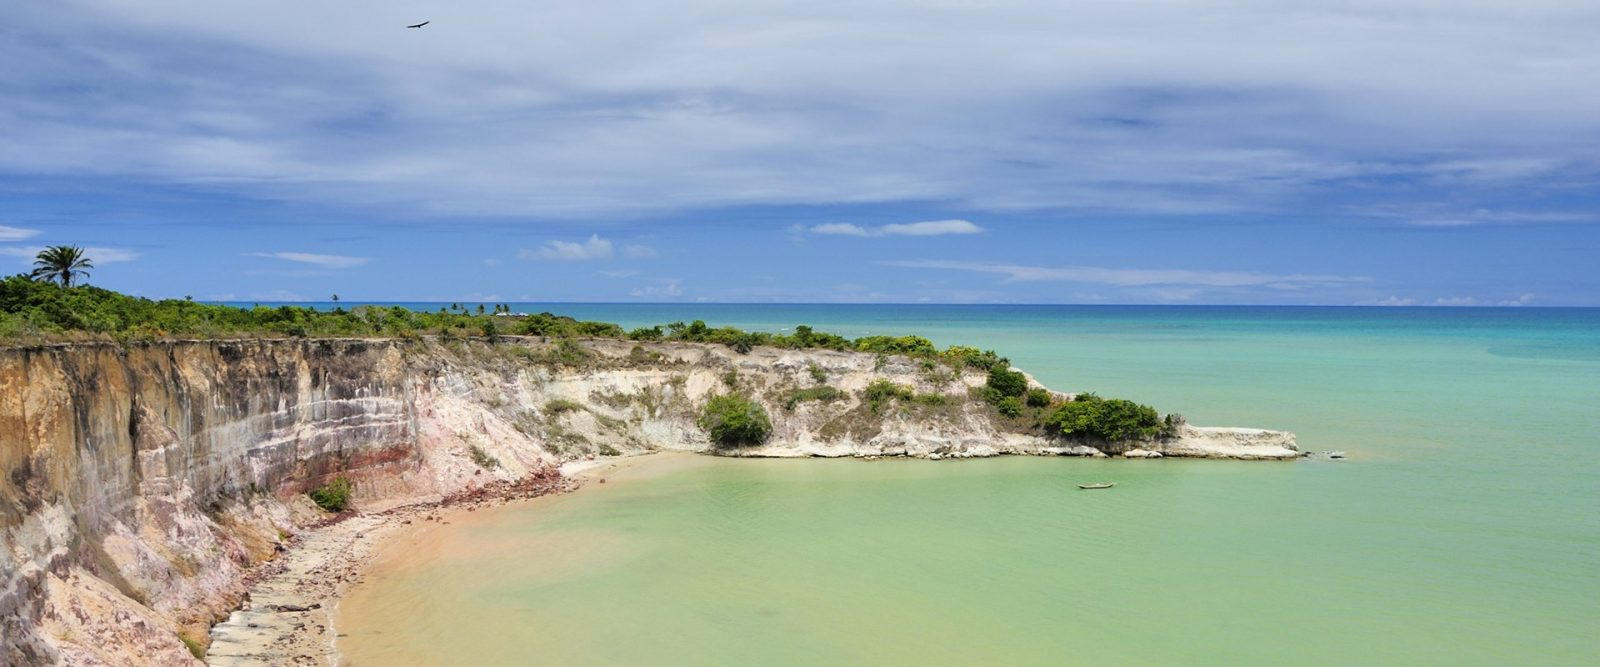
[{"xmin": 0, "ymin": 0, "xmax": 1600, "ymax": 306}]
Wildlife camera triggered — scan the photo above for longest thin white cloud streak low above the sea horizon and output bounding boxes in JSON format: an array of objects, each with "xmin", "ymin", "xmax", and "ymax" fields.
[{"xmin": 883, "ymin": 259, "xmax": 1370, "ymax": 287}]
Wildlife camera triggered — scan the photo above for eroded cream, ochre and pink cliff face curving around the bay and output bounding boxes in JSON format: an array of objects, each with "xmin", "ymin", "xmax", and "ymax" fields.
[{"xmin": 0, "ymin": 339, "xmax": 1298, "ymax": 664}]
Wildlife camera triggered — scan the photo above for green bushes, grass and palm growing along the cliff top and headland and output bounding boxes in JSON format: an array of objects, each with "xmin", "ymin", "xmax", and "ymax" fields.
[{"xmin": 0, "ymin": 270, "xmax": 1170, "ymax": 441}]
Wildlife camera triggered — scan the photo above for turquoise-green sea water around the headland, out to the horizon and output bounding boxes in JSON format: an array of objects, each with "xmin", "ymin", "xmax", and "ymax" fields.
[{"xmin": 341, "ymin": 304, "xmax": 1600, "ymax": 664}]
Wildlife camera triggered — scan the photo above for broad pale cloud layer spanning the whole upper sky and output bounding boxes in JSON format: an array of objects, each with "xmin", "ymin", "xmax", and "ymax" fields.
[{"xmin": 9, "ymin": 0, "xmax": 1600, "ymax": 218}]
